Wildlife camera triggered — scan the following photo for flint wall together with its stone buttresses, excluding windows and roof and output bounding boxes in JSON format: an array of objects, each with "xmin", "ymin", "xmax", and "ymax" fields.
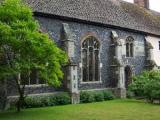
[{"xmin": 1, "ymin": 17, "xmax": 146, "ymax": 103}]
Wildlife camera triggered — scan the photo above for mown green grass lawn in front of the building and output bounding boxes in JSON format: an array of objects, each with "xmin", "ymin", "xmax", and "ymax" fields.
[{"xmin": 0, "ymin": 100, "xmax": 160, "ymax": 120}]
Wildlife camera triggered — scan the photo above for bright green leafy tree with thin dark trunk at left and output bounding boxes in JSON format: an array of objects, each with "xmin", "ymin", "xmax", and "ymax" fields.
[{"xmin": 0, "ymin": 0, "xmax": 67, "ymax": 111}]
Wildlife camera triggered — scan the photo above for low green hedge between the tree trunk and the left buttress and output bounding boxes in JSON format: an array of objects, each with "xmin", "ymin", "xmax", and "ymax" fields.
[{"xmin": 25, "ymin": 93, "xmax": 71, "ymax": 108}]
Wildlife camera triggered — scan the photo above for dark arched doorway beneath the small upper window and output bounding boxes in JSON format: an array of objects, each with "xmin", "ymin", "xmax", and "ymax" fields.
[{"xmin": 124, "ymin": 65, "xmax": 133, "ymax": 89}]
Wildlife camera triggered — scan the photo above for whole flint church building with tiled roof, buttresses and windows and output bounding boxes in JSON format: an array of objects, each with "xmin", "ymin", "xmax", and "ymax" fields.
[{"xmin": 0, "ymin": 0, "xmax": 160, "ymax": 103}]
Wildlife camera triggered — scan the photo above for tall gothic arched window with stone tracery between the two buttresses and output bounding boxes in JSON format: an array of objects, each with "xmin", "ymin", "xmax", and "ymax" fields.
[{"xmin": 82, "ymin": 36, "xmax": 100, "ymax": 82}]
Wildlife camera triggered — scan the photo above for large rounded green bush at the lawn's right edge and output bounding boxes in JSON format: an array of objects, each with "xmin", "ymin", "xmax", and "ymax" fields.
[{"xmin": 129, "ymin": 70, "xmax": 160, "ymax": 102}]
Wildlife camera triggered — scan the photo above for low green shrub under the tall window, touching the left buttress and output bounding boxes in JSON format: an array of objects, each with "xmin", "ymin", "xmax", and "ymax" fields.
[{"xmin": 80, "ymin": 91, "xmax": 94, "ymax": 103}]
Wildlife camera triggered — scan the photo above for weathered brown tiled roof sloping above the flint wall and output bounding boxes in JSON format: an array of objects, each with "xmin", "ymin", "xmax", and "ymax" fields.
[{"xmin": 25, "ymin": 0, "xmax": 160, "ymax": 35}]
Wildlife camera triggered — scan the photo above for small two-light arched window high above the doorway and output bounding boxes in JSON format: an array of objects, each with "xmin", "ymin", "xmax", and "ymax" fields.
[{"xmin": 126, "ymin": 37, "xmax": 134, "ymax": 57}]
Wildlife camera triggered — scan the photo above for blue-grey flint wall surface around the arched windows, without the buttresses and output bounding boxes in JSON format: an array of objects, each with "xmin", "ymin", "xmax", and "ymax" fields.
[{"xmin": 36, "ymin": 17, "xmax": 145, "ymax": 94}]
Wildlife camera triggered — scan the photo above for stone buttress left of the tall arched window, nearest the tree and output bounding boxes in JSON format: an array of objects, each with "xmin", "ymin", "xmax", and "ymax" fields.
[{"xmin": 61, "ymin": 23, "xmax": 79, "ymax": 104}]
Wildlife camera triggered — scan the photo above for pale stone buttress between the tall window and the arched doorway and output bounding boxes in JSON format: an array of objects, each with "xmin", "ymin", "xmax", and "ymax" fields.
[{"xmin": 111, "ymin": 31, "xmax": 126, "ymax": 98}]
